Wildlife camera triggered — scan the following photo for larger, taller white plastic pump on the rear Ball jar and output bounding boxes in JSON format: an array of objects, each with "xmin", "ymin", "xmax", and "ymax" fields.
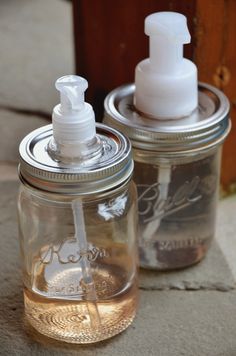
[{"xmin": 134, "ymin": 12, "xmax": 198, "ymax": 119}]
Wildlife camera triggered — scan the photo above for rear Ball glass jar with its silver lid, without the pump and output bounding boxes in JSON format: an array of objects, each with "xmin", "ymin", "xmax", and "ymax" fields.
[{"xmin": 104, "ymin": 83, "xmax": 230, "ymax": 270}]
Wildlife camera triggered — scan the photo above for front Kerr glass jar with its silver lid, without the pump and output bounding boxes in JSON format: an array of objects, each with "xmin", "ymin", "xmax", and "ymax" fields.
[{"xmin": 18, "ymin": 124, "xmax": 138, "ymax": 343}]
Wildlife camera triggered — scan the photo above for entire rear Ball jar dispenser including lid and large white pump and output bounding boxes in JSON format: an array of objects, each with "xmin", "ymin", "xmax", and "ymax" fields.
[{"xmin": 104, "ymin": 12, "xmax": 230, "ymax": 270}]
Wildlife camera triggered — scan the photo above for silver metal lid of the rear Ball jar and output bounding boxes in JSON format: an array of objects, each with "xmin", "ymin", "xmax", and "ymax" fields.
[{"xmin": 104, "ymin": 83, "xmax": 231, "ymax": 154}]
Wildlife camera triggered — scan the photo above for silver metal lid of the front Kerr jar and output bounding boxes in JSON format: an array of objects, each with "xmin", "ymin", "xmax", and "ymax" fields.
[{"xmin": 19, "ymin": 124, "xmax": 133, "ymax": 195}]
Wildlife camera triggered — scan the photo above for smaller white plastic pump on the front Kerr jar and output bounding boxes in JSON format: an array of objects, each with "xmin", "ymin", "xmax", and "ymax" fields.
[{"xmin": 52, "ymin": 75, "xmax": 96, "ymax": 157}]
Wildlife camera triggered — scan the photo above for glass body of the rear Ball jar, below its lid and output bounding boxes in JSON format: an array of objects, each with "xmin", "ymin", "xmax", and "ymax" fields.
[{"xmin": 134, "ymin": 147, "xmax": 221, "ymax": 270}]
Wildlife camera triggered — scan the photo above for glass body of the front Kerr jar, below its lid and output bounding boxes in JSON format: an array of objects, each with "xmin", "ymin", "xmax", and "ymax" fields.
[{"xmin": 18, "ymin": 177, "xmax": 137, "ymax": 343}]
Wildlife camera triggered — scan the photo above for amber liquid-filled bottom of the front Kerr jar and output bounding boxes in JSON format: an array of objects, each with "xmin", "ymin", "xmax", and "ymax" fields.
[{"xmin": 24, "ymin": 286, "xmax": 137, "ymax": 344}]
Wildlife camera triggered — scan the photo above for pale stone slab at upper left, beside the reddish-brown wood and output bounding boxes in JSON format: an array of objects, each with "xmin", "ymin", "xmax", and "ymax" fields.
[{"xmin": 0, "ymin": 0, "xmax": 74, "ymax": 113}]
